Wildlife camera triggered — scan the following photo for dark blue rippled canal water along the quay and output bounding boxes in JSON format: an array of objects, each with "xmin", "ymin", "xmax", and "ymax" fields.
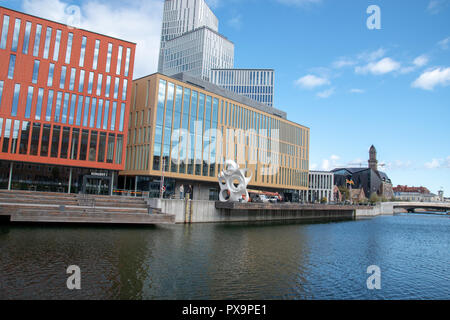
[{"xmin": 0, "ymin": 214, "xmax": 450, "ymax": 299}]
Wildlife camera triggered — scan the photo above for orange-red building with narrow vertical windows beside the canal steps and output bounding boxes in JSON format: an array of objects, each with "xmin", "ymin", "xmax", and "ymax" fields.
[{"xmin": 0, "ymin": 7, "xmax": 136, "ymax": 193}]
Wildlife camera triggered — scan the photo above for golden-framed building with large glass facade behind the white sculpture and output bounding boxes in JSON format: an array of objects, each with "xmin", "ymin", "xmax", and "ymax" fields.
[{"xmin": 119, "ymin": 73, "xmax": 309, "ymax": 200}]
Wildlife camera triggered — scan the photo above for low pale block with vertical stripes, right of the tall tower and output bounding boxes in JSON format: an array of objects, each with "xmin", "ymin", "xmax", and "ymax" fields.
[{"xmin": 211, "ymin": 69, "xmax": 275, "ymax": 107}]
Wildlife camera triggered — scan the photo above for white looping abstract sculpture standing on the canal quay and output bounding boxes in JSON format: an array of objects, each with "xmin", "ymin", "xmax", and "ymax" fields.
[{"xmin": 219, "ymin": 160, "xmax": 252, "ymax": 202}]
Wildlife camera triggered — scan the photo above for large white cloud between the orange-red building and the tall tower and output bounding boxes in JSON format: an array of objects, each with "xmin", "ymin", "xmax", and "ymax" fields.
[{"xmin": 23, "ymin": 0, "xmax": 163, "ymax": 78}]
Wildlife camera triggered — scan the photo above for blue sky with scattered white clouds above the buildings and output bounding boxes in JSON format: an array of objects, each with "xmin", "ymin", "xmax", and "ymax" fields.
[{"xmin": 0, "ymin": 0, "xmax": 450, "ymax": 197}]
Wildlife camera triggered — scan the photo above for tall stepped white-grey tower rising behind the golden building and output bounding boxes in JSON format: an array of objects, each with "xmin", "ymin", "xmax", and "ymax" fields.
[{"xmin": 158, "ymin": 0, "xmax": 234, "ymax": 81}]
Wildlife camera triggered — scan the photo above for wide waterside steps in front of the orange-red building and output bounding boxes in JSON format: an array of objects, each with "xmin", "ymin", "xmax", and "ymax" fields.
[{"xmin": 0, "ymin": 190, "xmax": 175, "ymax": 224}]
